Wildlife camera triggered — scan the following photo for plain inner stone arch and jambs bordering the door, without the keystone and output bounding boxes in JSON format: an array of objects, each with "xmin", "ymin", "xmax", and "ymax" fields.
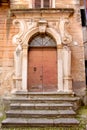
[{"xmin": 22, "ymin": 24, "xmax": 63, "ymax": 91}]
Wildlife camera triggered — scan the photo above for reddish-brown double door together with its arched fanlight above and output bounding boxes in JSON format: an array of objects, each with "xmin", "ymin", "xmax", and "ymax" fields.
[{"xmin": 28, "ymin": 35, "xmax": 57, "ymax": 92}]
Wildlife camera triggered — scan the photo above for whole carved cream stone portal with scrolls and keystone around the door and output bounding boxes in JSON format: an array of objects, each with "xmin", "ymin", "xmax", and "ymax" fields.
[{"xmin": 13, "ymin": 18, "xmax": 72, "ymax": 92}]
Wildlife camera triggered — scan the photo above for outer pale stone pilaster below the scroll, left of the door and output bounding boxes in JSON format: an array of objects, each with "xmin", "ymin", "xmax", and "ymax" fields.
[{"xmin": 13, "ymin": 44, "xmax": 22, "ymax": 91}]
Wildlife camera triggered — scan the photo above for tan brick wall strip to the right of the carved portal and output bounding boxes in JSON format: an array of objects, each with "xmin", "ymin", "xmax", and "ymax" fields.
[{"xmin": 69, "ymin": 4, "xmax": 85, "ymax": 94}]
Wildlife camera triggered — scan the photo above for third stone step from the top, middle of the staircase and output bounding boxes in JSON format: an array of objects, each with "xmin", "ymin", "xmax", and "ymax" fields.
[{"xmin": 10, "ymin": 103, "xmax": 73, "ymax": 110}]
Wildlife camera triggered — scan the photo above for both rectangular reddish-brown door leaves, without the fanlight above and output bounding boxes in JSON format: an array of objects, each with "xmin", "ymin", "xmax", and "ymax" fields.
[{"xmin": 28, "ymin": 48, "xmax": 57, "ymax": 92}]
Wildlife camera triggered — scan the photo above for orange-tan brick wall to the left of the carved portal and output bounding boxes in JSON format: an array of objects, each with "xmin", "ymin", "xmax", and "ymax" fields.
[{"xmin": 0, "ymin": 5, "xmax": 16, "ymax": 94}]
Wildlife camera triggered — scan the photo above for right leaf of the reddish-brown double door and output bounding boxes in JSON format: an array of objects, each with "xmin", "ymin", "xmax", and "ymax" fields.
[{"xmin": 43, "ymin": 48, "xmax": 57, "ymax": 91}]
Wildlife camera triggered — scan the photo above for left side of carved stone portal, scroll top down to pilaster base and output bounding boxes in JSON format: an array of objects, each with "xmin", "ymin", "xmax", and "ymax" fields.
[{"xmin": 12, "ymin": 19, "xmax": 36, "ymax": 92}]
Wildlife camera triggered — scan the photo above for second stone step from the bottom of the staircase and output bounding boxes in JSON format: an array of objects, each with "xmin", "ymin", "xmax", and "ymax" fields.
[{"xmin": 6, "ymin": 110, "xmax": 76, "ymax": 118}]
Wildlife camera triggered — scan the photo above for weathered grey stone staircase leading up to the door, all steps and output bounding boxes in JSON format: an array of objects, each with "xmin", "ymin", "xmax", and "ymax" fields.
[{"xmin": 2, "ymin": 92, "xmax": 80, "ymax": 127}]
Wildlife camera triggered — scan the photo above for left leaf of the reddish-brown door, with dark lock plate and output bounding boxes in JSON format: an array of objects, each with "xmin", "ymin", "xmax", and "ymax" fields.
[{"xmin": 28, "ymin": 48, "xmax": 42, "ymax": 91}]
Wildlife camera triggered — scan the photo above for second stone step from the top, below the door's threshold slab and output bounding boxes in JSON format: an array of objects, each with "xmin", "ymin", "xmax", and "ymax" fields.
[{"xmin": 10, "ymin": 97, "xmax": 80, "ymax": 110}]
